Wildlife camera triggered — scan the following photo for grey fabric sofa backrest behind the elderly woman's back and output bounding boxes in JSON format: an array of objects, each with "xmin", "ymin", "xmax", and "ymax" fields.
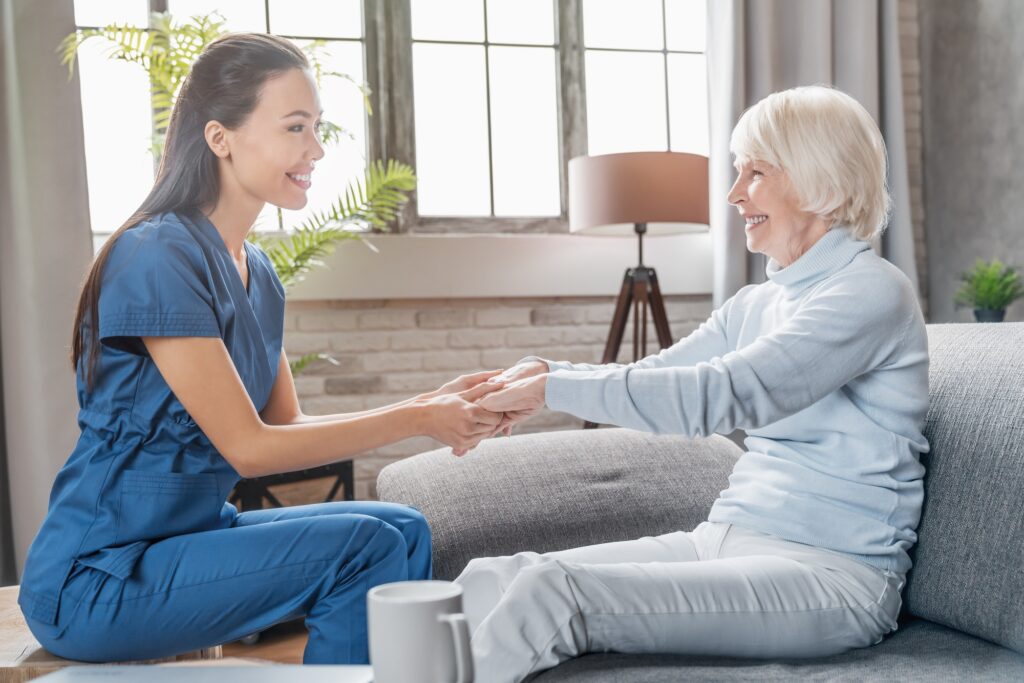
[{"xmin": 905, "ymin": 323, "xmax": 1024, "ymax": 653}]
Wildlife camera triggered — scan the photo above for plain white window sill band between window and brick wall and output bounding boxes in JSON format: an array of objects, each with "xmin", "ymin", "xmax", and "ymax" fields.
[{"xmin": 280, "ymin": 232, "xmax": 712, "ymax": 301}]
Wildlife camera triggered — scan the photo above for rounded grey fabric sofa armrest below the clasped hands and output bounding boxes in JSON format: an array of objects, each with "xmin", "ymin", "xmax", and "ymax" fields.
[{"xmin": 377, "ymin": 428, "xmax": 742, "ymax": 579}]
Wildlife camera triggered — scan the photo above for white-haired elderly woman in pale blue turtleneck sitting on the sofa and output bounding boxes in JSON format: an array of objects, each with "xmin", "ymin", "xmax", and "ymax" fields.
[{"xmin": 468, "ymin": 87, "xmax": 928, "ymax": 682}]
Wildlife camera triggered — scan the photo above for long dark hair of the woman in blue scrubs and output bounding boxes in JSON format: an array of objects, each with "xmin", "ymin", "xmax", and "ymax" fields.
[{"xmin": 71, "ymin": 33, "xmax": 309, "ymax": 390}]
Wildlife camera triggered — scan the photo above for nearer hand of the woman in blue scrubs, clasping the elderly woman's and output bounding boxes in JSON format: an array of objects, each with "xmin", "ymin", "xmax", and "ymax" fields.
[{"xmin": 417, "ymin": 382, "xmax": 505, "ymax": 455}]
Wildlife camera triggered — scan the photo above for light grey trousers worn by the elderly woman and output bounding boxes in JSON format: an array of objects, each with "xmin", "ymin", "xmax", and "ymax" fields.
[{"xmin": 456, "ymin": 521, "xmax": 905, "ymax": 683}]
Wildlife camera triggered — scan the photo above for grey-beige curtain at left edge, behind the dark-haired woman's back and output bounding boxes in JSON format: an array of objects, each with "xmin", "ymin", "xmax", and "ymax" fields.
[{"xmin": 0, "ymin": 0, "xmax": 92, "ymax": 584}]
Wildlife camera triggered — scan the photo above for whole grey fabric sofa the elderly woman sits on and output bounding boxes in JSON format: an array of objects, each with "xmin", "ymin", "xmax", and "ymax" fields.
[{"xmin": 378, "ymin": 323, "xmax": 1024, "ymax": 683}]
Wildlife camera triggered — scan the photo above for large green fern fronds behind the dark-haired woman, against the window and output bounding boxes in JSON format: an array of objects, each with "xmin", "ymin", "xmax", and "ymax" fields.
[{"xmin": 58, "ymin": 12, "xmax": 416, "ymax": 374}]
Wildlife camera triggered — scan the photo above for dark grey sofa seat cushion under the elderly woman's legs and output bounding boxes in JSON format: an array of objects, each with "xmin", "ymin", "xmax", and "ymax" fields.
[{"xmin": 534, "ymin": 620, "xmax": 1024, "ymax": 683}]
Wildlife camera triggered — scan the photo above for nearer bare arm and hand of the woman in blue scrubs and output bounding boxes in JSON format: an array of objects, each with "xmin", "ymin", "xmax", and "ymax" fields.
[{"xmin": 142, "ymin": 337, "xmax": 502, "ymax": 478}]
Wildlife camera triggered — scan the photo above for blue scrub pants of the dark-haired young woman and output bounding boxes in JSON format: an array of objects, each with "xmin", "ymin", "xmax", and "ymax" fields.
[{"xmin": 29, "ymin": 502, "xmax": 431, "ymax": 664}]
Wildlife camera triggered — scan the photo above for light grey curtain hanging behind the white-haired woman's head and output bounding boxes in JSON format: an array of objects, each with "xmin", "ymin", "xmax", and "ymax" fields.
[{"xmin": 708, "ymin": 0, "xmax": 918, "ymax": 307}]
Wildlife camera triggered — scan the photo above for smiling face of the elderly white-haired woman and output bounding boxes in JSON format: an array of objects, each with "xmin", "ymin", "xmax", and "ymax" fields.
[{"xmin": 728, "ymin": 160, "xmax": 828, "ymax": 267}]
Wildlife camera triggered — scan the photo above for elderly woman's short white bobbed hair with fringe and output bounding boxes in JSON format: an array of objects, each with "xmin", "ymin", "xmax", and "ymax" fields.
[{"xmin": 729, "ymin": 86, "xmax": 892, "ymax": 241}]
